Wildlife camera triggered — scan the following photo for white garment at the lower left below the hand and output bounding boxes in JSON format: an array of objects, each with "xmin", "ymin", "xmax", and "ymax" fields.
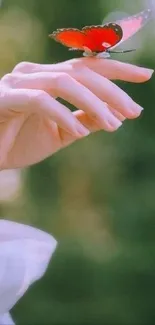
[{"xmin": 0, "ymin": 220, "xmax": 57, "ymax": 325}]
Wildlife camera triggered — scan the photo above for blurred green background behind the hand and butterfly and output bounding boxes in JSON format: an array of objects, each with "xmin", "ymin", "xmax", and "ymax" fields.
[{"xmin": 0, "ymin": 0, "xmax": 155, "ymax": 325}]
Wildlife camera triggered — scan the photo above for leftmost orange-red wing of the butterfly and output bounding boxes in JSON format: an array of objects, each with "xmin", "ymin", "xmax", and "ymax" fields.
[{"xmin": 49, "ymin": 28, "xmax": 86, "ymax": 50}]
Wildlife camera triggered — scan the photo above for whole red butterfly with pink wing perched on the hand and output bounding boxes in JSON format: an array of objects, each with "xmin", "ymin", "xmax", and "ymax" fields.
[{"xmin": 49, "ymin": 9, "xmax": 151, "ymax": 57}]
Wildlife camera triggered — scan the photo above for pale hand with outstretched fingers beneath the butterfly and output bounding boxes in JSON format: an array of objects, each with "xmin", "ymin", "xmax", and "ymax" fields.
[{"xmin": 0, "ymin": 58, "xmax": 153, "ymax": 170}]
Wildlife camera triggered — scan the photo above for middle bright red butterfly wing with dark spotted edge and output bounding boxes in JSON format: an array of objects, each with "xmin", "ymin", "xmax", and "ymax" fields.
[{"xmin": 82, "ymin": 23, "xmax": 123, "ymax": 52}]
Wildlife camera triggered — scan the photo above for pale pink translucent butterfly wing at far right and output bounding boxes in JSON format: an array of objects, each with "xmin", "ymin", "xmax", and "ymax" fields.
[{"xmin": 113, "ymin": 9, "xmax": 152, "ymax": 48}]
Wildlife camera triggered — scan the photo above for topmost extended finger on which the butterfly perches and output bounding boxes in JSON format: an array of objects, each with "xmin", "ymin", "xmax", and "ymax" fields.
[{"xmin": 13, "ymin": 57, "xmax": 154, "ymax": 83}]
